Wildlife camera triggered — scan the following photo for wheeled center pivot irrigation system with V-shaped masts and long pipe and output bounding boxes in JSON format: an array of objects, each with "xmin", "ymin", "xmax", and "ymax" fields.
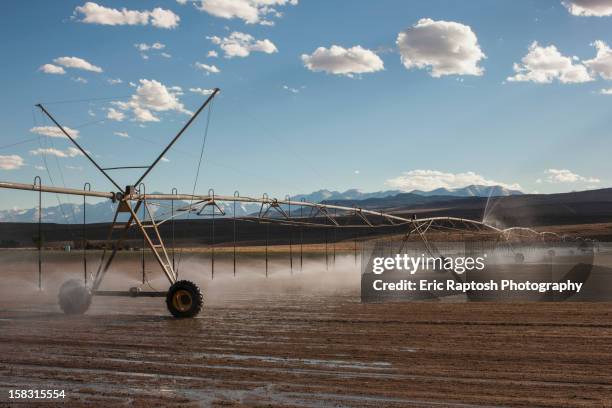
[{"xmin": 0, "ymin": 88, "xmax": 580, "ymax": 318}]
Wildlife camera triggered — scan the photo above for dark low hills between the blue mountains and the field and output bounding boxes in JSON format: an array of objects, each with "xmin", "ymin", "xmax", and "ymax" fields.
[{"xmin": 0, "ymin": 188, "xmax": 612, "ymax": 247}]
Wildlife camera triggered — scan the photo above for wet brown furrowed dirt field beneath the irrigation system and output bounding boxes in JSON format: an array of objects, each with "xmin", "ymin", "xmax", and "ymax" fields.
[{"xmin": 0, "ymin": 252, "xmax": 612, "ymax": 407}]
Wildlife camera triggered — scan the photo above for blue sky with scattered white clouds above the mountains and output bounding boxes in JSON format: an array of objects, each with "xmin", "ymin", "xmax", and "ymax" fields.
[{"xmin": 0, "ymin": 0, "xmax": 612, "ymax": 209}]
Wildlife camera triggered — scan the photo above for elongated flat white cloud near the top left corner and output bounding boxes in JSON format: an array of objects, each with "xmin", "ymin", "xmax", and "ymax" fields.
[{"xmin": 74, "ymin": 1, "xmax": 181, "ymax": 29}]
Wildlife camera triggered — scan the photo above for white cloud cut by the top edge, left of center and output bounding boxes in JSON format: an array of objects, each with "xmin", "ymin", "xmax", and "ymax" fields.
[{"xmin": 197, "ymin": 0, "xmax": 298, "ymax": 25}]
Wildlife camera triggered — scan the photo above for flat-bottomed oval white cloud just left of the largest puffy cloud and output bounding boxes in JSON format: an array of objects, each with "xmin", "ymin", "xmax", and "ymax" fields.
[{"xmin": 301, "ymin": 45, "xmax": 385, "ymax": 77}]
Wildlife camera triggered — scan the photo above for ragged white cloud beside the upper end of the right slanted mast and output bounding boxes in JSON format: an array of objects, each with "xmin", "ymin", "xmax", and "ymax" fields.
[{"xmin": 109, "ymin": 79, "xmax": 191, "ymax": 122}]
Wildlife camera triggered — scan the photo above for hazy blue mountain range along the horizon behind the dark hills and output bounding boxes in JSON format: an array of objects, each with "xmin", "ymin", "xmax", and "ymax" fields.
[{"xmin": 0, "ymin": 185, "xmax": 523, "ymax": 224}]
